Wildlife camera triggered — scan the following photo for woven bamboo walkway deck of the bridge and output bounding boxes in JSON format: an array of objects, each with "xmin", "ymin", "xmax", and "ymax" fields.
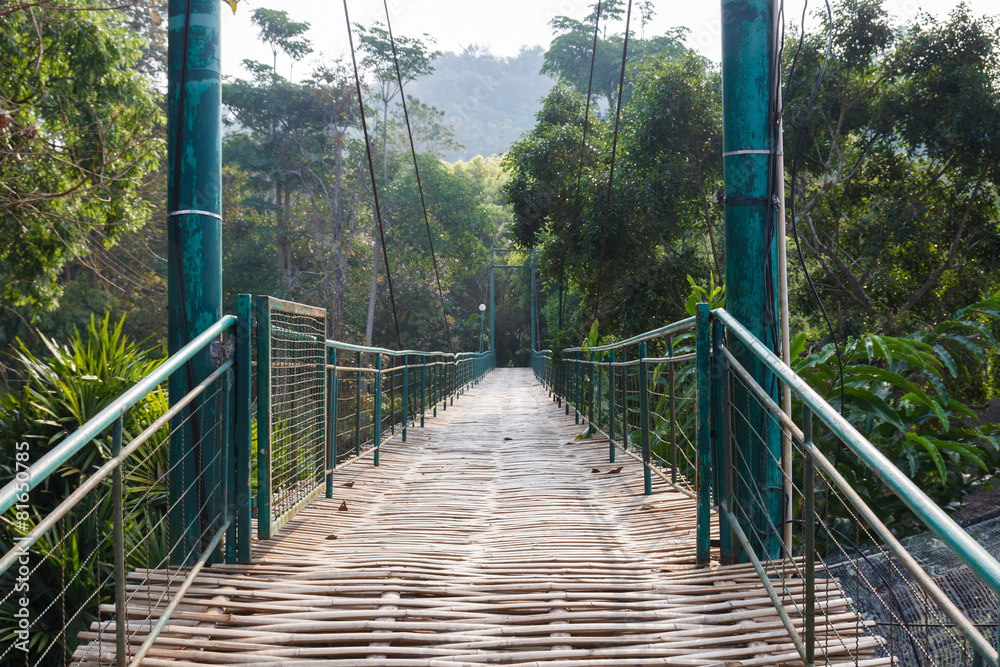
[{"xmin": 86, "ymin": 370, "xmax": 890, "ymax": 667}]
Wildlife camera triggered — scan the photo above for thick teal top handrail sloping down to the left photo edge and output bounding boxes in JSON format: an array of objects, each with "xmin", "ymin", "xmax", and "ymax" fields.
[{"xmin": 0, "ymin": 315, "xmax": 236, "ymax": 514}]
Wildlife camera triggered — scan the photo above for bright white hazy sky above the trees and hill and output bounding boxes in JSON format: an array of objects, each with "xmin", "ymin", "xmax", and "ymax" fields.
[{"xmin": 223, "ymin": 0, "xmax": 998, "ymax": 78}]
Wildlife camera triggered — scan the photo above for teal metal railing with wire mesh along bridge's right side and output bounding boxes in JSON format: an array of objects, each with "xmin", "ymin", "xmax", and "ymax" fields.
[{"xmin": 533, "ymin": 305, "xmax": 1000, "ymax": 666}]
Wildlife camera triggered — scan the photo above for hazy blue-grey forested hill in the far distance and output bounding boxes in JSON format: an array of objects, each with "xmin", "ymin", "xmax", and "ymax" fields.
[{"xmin": 407, "ymin": 46, "xmax": 554, "ymax": 160}]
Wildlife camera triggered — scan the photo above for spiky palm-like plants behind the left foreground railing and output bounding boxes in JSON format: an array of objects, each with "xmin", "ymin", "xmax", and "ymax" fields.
[{"xmin": 0, "ymin": 316, "xmax": 170, "ymax": 665}]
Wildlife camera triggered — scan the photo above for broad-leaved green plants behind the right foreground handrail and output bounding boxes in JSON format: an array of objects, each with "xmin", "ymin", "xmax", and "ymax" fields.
[{"xmin": 792, "ymin": 298, "xmax": 1000, "ymax": 529}]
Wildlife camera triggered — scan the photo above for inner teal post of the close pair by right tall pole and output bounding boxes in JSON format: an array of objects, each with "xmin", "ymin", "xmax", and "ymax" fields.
[{"xmin": 696, "ymin": 303, "xmax": 712, "ymax": 565}]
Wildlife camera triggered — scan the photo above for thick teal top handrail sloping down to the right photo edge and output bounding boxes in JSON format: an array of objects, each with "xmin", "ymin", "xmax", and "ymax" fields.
[{"xmin": 713, "ymin": 308, "xmax": 1000, "ymax": 594}]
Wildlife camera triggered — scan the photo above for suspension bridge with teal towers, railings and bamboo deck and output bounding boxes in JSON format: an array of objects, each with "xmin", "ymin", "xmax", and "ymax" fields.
[{"xmin": 0, "ymin": 0, "xmax": 1000, "ymax": 667}]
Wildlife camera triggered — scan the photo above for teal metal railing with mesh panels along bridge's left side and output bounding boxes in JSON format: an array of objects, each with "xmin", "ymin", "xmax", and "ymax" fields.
[{"xmin": 0, "ymin": 295, "xmax": 494, "ymax": 667}]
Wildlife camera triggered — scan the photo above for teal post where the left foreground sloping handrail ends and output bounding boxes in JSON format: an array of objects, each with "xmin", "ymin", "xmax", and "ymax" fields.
[{"xmin": 235, "ymin": 294, "xmax": 253, "ymax": 563}]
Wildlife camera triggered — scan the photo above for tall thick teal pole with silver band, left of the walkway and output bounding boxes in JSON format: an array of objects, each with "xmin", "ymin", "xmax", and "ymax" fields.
[{"xmin": 167, "ymin": 0, "xmax": 222, "ymax": 566}]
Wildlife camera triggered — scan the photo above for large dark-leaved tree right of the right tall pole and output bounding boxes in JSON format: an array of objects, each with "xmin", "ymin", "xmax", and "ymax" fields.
[{"xmin": 785, "ymin": 0, "xmax": 1000, "ymax": 333}]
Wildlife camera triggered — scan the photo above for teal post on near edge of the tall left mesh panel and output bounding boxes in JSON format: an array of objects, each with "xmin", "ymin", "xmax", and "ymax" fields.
[{"xmin": 257, "ymin": 296, "xmax": 271, "ymax": 540}]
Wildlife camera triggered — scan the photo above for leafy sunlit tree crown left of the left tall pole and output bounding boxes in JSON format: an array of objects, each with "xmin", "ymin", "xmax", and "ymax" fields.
[{"xmin": 0, "ymin": 0, "xmax": 163, "ymax": 309}]
